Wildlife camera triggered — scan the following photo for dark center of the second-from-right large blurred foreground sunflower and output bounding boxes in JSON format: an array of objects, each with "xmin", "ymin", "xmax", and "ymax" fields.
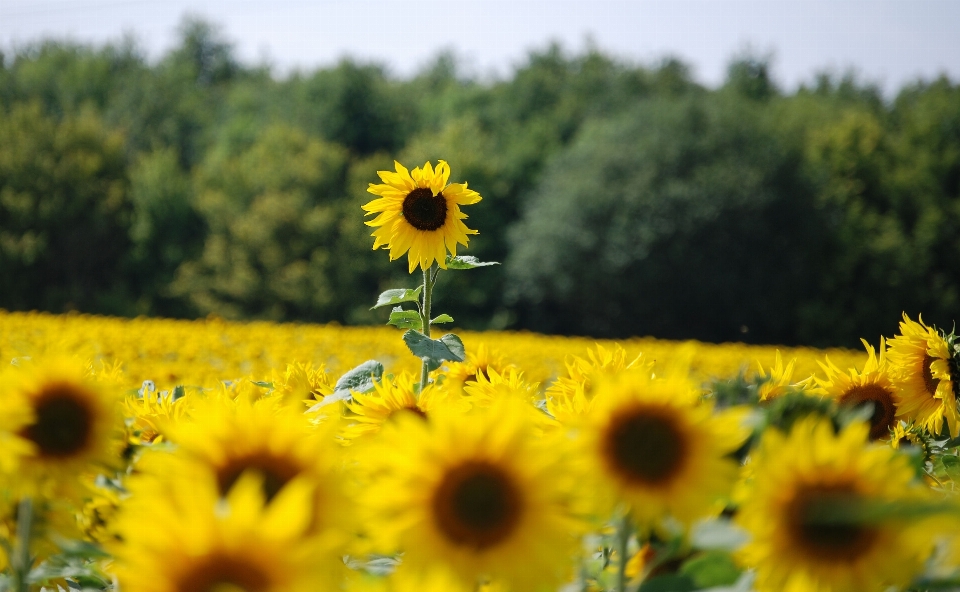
[{"xmin": 603, "ymin": 409, "xmax": 687, "ymax": 485}]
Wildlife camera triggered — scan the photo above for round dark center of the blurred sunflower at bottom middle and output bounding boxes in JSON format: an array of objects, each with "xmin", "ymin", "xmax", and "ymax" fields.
[{"xmin": 433, "ymin": 462, "xmax": 523, "ymax": 550}]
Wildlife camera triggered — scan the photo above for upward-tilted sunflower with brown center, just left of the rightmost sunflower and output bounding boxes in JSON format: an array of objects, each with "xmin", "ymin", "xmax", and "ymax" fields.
[{"xmin": 813, "ymin": 338, "xmax": 900, "ymax": 440}]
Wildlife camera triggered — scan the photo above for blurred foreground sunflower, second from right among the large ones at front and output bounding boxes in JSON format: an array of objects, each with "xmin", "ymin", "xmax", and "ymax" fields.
[{"xmin": 578, "ymin": 372, "xmax": 747, "ymax": 526}]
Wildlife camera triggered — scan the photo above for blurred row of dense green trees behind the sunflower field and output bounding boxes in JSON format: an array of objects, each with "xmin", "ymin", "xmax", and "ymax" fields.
[{"xmin": 0, "ymin": 21, "xmax": 960, "ymax": 345}]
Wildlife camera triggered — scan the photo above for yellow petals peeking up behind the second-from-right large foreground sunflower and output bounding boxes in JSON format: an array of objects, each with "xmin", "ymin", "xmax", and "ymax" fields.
[{"xmin": 546, "ymin": 344, "xmax": 653, "ymax": 422}]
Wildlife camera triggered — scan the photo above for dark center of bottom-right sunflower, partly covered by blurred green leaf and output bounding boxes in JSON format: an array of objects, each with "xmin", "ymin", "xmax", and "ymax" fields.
[{"xmin": 788, "ymin": 487, "xmax": 879, "ymax": 563}]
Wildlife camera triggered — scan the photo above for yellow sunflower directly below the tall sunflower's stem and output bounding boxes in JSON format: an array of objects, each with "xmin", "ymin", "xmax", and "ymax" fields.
[{"xmin": 341, "ymin": 372, "xmax": 465, "ymax": 443}]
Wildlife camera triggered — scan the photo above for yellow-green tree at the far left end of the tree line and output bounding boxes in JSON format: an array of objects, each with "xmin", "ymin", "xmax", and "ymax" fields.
[{"xmin": 0, "ymin": 102, "xmax": 131, "ymax": 314}]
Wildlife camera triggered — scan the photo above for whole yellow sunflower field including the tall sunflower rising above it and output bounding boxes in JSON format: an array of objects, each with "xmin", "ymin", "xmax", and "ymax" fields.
[{"xmin": 0, "ymin": 156, "xmax": 960, "ymax": 592}]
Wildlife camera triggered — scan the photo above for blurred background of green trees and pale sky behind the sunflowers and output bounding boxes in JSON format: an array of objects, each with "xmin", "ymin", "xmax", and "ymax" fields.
[{"xmin": 0, "ymin": 0, "xmax": 960, "ymax": 346}]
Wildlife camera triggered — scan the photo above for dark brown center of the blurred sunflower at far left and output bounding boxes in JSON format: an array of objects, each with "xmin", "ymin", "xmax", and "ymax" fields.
[{"xmin": 21, "ymin": 383, "xmax": 93, "ymax": 458}]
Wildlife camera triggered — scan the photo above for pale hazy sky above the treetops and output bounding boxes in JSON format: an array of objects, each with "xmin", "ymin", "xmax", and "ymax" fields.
[{"xmin": 0, "ymin": 0, "xmax": 960, "ymax": 92}]
